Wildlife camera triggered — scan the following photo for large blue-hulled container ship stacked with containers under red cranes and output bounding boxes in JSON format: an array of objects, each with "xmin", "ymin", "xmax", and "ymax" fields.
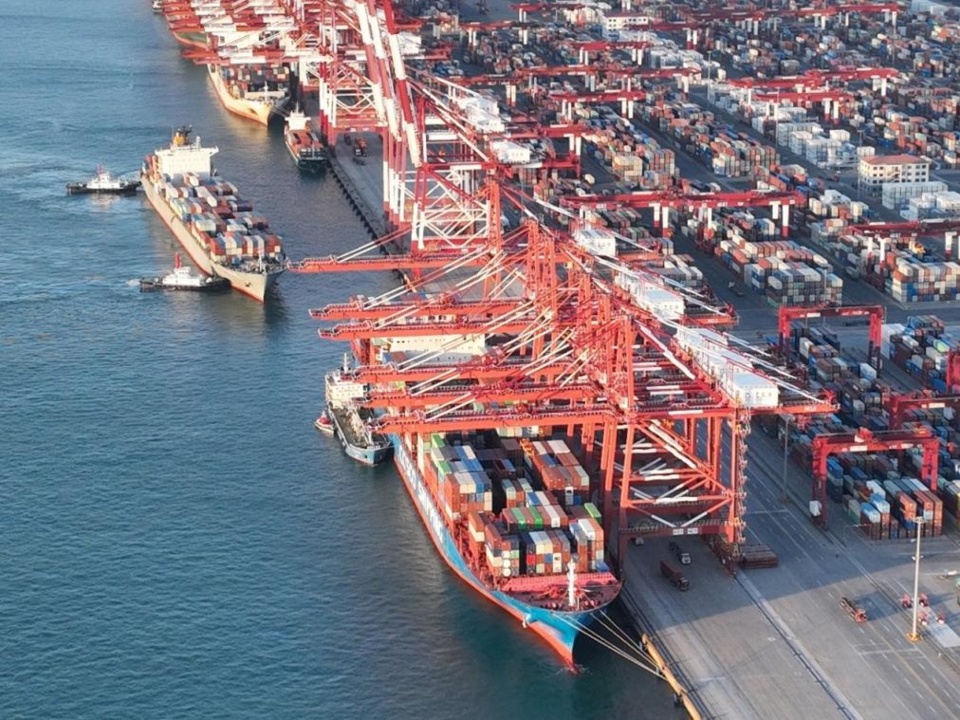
[{"xmin": 390, "ymin": 432, "xmax": 620, "ymax": 665}]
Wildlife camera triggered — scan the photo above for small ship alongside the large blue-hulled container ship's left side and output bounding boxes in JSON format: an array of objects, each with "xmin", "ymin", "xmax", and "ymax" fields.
[{"xmin": 324, "ymin": 356, "xmax": 393, "ymax": 465}]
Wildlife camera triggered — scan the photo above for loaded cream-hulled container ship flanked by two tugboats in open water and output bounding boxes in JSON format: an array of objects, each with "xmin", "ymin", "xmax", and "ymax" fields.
[{"xmin": 140, "ymin": 127, "xmax": 287, "ymax": 303}]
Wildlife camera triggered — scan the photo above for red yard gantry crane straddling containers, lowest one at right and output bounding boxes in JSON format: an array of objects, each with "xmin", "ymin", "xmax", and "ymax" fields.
[{"xmin": 811, "ymin": 428, "xmax": 940, "ymax": 527}]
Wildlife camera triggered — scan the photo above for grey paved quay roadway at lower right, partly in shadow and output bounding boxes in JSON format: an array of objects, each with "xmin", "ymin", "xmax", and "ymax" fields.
[{"xmin": 624, "ymin": 416, "xmax": 960, "ymax": 720}]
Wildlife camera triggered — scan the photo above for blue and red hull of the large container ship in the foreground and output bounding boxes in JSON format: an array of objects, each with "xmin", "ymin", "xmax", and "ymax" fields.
[{"xmin": 388, "ymin": 435, "xmax": 601, "ymax": 665}]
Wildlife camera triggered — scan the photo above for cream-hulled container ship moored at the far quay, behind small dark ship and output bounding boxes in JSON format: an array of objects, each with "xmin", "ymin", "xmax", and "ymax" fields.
[{"xmin": 207, "ymin": 63, "xmax": 290, "ymax": 126}]
